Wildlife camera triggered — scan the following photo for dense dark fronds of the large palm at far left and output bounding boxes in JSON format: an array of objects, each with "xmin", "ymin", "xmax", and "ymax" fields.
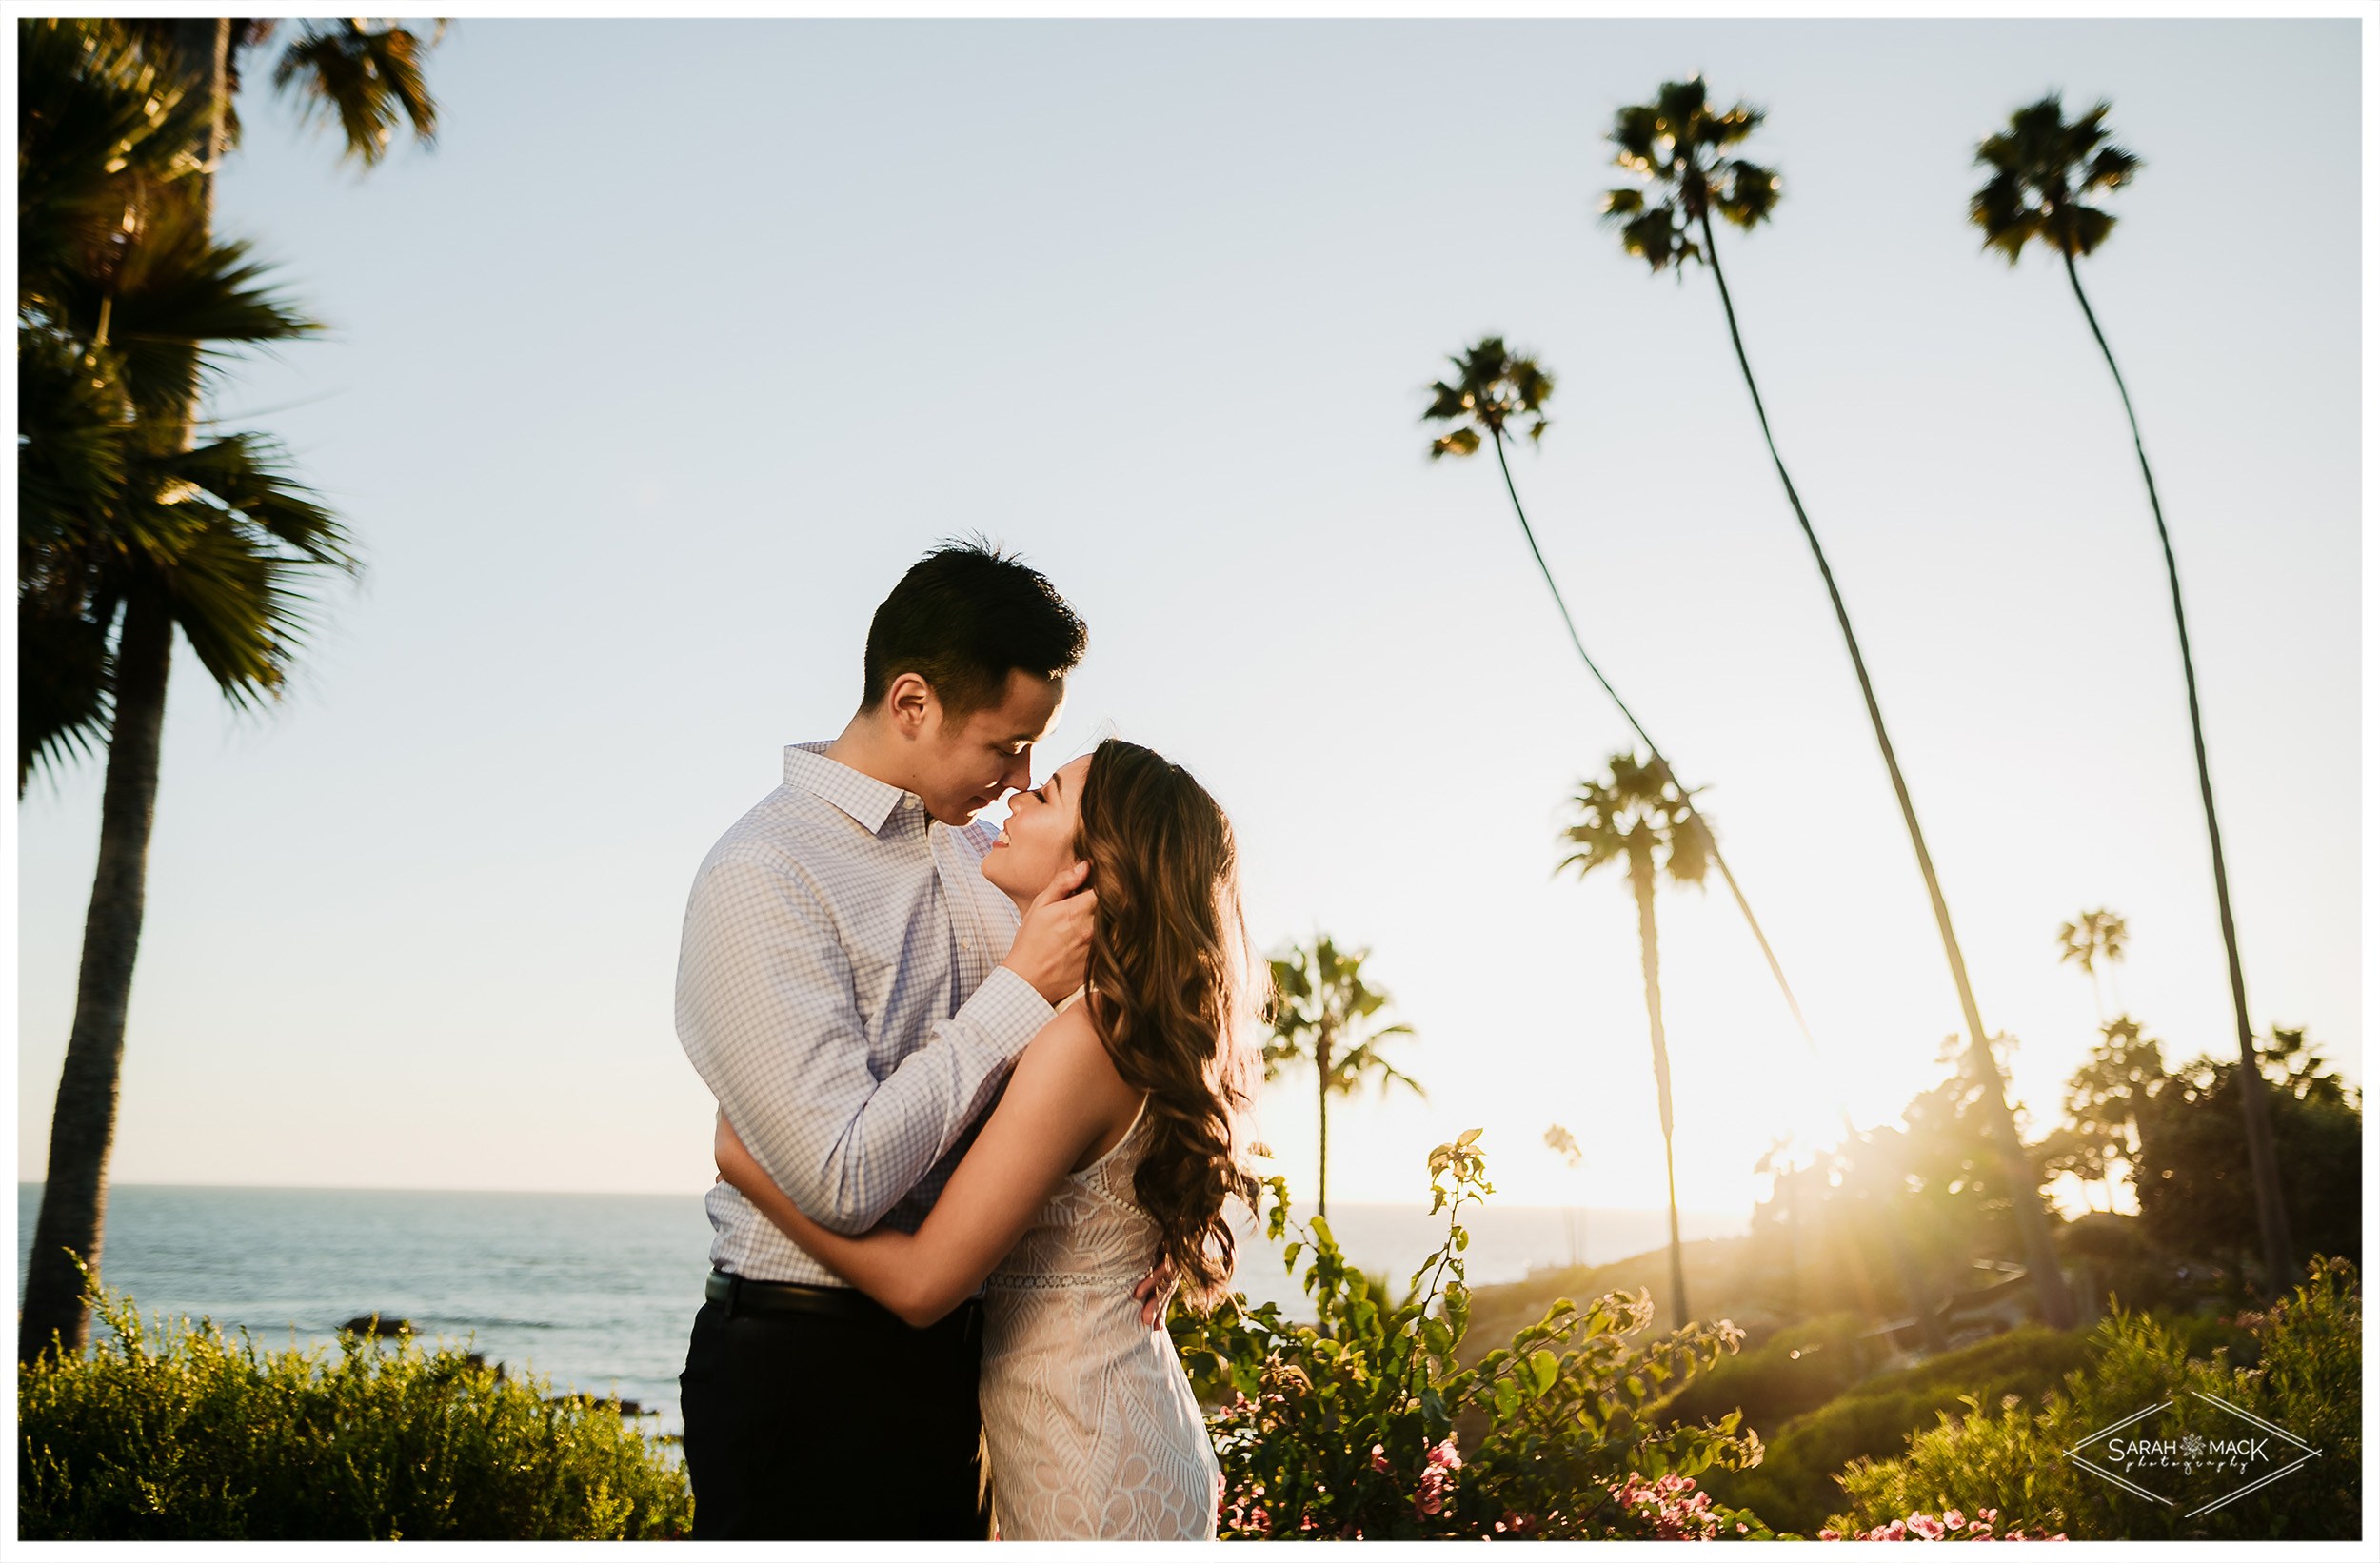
[{"xmin": 17, "ymin": 19, "xmax": 355, "ymax": 792}]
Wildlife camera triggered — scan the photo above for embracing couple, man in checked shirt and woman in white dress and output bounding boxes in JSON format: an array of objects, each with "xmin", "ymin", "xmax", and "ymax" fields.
[{"xmin": 679, "ymin": 544, "xmax": 1255, "ymax": 1539}]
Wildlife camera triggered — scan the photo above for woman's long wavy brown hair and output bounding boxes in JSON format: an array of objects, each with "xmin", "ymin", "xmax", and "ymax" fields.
[{"xmin": 1076, "ymin": 738, "xmax": 1257, "ymax": 1309}]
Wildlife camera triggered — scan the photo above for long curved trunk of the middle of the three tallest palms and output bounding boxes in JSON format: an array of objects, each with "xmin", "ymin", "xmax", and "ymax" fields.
[{"xmin": 1702, "ymin": 211, "xmax": 2075, "ymax": 1330}]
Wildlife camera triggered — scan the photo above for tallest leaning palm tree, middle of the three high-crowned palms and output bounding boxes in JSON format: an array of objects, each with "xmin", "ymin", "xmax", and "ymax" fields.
[{"xmin": 1604, "ymin": 76, "xmax": 2075, "ymax": 1330}]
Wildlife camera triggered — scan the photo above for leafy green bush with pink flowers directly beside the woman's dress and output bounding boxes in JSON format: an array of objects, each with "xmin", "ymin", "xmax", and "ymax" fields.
[{"xmin": 1174, "ymin": 1130, "xmax": 1769, "ymax": 1539}]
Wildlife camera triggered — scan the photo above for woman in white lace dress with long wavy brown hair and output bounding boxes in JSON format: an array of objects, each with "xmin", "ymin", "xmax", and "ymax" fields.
[{"xmin": 719, "ymin": 740, "xmax": 1255, "ymax": 1542}]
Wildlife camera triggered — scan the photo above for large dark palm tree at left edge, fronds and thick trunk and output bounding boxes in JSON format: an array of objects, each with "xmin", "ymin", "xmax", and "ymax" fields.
[{"xmin": 17, "ymin": 21, "xmax": 426, "ymax": 1361}]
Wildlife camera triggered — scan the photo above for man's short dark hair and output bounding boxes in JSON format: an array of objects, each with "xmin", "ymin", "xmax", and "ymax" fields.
[{"xmin": 860, "ymin": 538, "xmax": 1088, "ymax": 716}]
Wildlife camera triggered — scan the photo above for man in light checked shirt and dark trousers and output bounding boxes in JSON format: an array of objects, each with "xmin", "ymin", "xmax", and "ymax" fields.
[{"xmin": 679, "ymin": 544, "xmax": 1093, "ymax": 1542}]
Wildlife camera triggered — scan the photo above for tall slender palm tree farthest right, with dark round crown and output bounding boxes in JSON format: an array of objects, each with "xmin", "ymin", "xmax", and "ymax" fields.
[{"xmin": 1969, "ymin": 92, "xmax": 2297, "ymax": 1295}]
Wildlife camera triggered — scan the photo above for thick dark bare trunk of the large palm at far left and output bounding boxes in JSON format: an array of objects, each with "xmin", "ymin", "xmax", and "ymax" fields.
[{"xmin": 17, "ymin": 595, "xmax": 174, "ymax": 1363}]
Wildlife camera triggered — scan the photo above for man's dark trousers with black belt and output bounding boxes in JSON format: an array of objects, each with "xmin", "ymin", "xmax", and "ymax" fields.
[{"xmin": 679, "ymin": 1301, "xmax": 993, "ymax": 1542}]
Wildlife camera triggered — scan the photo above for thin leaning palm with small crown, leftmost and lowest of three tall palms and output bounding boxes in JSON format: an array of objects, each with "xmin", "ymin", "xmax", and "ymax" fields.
[{"xmin": 1421, "ymin": 335, "xmax": 1950, "ymax": 1352}]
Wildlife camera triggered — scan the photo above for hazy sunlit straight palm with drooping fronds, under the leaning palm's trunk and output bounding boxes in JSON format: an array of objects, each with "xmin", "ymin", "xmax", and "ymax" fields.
[{"xmin": 1555, "ymin": 754, "xmax": 1712, "ymax": 1325}]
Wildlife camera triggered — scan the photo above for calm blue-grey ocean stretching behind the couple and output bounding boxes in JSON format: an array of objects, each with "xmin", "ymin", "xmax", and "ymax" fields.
[{"xmin": 17, "ymin": 1182, "xmax": 1745, "ymax": 1434}]
